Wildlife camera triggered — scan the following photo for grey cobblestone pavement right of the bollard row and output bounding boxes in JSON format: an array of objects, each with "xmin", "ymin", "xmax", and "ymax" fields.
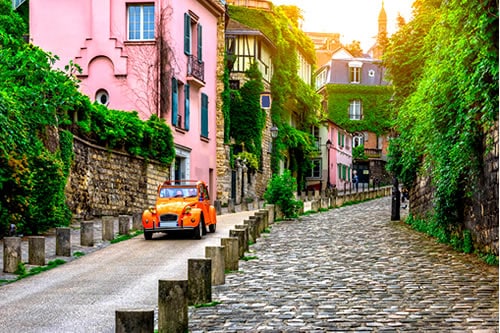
[{"xmin": 189, "ymin": 197, "xmax": 499, "ymax": 333}]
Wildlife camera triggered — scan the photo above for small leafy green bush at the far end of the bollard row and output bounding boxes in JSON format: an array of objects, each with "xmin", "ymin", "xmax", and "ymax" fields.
[{"xmin": 264, "ymin": 170, "xmax": 303, "ymax": 217}]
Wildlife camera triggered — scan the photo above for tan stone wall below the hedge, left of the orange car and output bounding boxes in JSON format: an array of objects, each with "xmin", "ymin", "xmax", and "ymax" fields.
[{"xmin": 66, "ymin": 137, "xmax": 169, "ymax": 218}]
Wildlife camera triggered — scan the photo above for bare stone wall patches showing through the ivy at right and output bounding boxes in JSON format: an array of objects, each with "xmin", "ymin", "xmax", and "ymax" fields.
[{"xmin": 410, "ymin": 122, "xmax": 499, "ymax": 255}]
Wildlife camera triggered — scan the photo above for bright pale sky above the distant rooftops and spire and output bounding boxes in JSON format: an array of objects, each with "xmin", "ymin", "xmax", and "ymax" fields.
[{"xmin": 272, "ymin": 0, "xmax": 414, "ymax": 51}]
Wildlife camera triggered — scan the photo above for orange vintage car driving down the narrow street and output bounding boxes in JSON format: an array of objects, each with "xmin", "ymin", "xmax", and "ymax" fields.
[{"xmin": 142, "ymin": 180, "xmax": 217, "ymax": 240}]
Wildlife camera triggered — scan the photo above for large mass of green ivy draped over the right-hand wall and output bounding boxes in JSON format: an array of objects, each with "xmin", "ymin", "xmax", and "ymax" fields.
[{"xmin": 386, "ymin": 0, "xmax": 499, "ymax": 244}]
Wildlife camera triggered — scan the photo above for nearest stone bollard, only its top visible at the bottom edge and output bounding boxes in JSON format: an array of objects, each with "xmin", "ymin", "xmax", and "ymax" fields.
[{"xmin": 115, "ymin": 309, "xmax": 155, "ymax": 333}]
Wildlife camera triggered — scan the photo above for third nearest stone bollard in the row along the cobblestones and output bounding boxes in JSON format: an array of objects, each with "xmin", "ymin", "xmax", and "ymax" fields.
[{"xmin": 188, "ymin": 258, "xmax": 212, "ymax": 305}]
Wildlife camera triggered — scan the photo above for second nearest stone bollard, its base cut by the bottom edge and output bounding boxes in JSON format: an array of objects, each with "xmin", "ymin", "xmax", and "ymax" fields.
[{"xmin": 158, "ymin": 280, "xmax": 188, "ymax": 333}]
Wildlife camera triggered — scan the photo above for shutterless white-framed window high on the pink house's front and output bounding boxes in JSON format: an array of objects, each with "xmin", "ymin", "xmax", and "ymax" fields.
[{"xmin": 127, "ymin": 5, "xmax": 155, "ymax": 40}]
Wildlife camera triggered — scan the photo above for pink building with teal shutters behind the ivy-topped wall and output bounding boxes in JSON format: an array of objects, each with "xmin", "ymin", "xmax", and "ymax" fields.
[{"xmin": 29, "ymin": 0, "xmax": 225, "ymax": 198}]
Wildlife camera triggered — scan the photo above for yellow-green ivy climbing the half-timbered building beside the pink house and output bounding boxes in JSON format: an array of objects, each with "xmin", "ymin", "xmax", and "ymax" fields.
[{"xmin": 229, "ymin": 6, "xmax": 320, "ymax": 182}]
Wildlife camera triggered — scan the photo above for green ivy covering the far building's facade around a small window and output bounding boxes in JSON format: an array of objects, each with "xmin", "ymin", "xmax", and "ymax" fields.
[{"xmin": 327, "ymin": 84, "xmax": 393, "ymax": 135}]
